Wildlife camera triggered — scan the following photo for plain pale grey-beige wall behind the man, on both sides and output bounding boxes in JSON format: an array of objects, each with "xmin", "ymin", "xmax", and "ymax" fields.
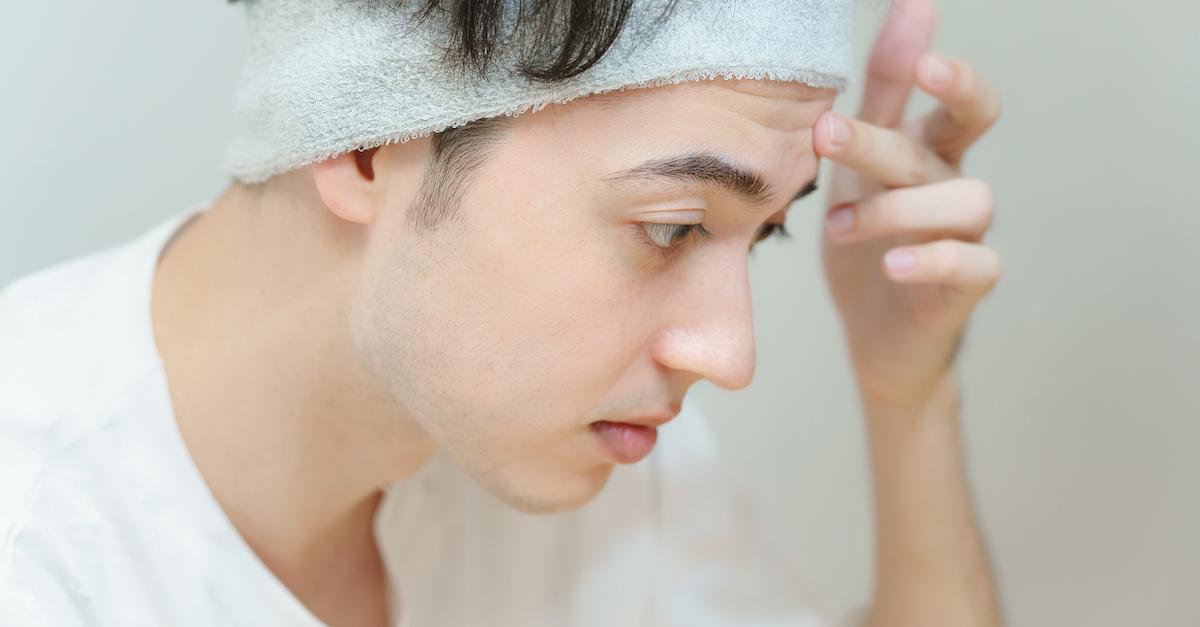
[{"xmin": 0, "ymin": 0, "xmax": 1200, "ymax": 627}]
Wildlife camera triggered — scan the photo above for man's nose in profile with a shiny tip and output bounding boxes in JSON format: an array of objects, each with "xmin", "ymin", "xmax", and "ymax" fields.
[{"xmin": 655, "ymin": 252, "xmax": 755, "ymax": 390}]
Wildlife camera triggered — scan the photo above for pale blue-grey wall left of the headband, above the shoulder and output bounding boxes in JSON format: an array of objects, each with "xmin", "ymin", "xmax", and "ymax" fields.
[{"xmin": 0, "ymin": 0, "xmax": 245, "ymax": 276}]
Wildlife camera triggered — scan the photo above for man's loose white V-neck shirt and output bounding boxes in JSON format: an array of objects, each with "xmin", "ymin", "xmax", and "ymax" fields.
[{"xmin": 0, "ymin": 203, "xmax": 844, "ymax": 627}]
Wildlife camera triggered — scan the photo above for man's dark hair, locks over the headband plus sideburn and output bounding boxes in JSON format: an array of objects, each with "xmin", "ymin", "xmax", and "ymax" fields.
[{"xmin": 229, "ymin": 0, "xmax": 676, "ymax": 228}]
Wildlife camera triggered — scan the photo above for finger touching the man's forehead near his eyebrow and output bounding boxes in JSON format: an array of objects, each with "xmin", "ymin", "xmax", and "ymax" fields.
[{"xmin": 812, "ymin": 111, "xmax": 959, "ymax": 187}]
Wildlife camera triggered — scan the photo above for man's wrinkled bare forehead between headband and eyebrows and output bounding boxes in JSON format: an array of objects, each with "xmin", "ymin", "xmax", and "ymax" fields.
[{"xmin": 516, "ymin": 79, "xmax": 836, "ymax": 193}]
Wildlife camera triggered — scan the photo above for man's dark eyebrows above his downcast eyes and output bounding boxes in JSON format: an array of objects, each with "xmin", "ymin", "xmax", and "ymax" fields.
[{"xmin": 606, "ymin": 153, "xmax": 820, "ymax": 212}]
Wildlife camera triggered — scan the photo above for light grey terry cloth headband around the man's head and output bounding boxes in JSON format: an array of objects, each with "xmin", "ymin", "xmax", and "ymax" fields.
[{"xmin": 224, "ymin": 0, "xmax": 853, "ymax": 183}]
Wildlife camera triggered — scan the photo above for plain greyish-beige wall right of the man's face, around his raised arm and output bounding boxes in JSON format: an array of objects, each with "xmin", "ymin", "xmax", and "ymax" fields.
[{"xmin": 700, "ymin": 0, "xmax": 1200, "ymax": 627}]
